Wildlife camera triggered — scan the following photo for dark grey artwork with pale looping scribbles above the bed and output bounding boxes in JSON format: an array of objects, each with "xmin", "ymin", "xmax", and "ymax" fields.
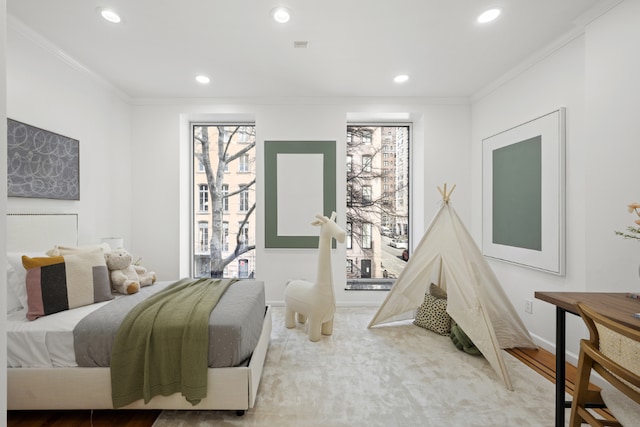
[{"xmin": 7, "ymin": 119, "xmax": 80, "ymax": 200}]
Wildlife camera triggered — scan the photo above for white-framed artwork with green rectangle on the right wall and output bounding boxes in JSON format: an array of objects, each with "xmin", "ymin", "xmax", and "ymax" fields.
[{"xmin": 482, "ymin": 108, "xmax": 565, "ymax": 275}]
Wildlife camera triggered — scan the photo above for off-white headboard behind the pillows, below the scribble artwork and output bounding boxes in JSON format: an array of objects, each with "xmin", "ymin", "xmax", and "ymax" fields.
[{"xmin": 7, "ymin": 213, "xmax": 78, "ymax": 252}]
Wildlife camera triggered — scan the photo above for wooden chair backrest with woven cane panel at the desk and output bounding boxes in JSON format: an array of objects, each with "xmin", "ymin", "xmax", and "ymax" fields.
[{"xmin": 578, "ymin": 303, "xmax": 640, "ymax": 404}]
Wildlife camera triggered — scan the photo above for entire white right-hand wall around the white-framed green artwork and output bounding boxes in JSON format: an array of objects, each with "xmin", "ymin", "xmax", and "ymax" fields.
[{"xmin": 471, "ymin": 1, "xmax": 640, "ymax": 363}]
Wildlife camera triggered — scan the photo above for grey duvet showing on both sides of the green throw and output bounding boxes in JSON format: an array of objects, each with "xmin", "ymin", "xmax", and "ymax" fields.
[{"xmin": 73, "ymin": 280, "xmax": 265, "ymax": 368}]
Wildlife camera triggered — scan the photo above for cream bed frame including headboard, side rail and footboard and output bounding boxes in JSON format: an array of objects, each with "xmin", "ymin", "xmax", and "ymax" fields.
[{"xmin": 7, "ymin": 214, "xmax": 272, "ymax": 412}]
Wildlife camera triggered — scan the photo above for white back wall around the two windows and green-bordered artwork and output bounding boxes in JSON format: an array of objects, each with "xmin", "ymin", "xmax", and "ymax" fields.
[{"xmin": 132, "ymin": 99, "xmax": 470, "ymax": 305}]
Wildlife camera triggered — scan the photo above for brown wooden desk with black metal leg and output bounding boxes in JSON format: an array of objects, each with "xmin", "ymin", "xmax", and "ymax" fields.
[{"xmin": 535, "ymin": 292, "xmax": 640, "ymax": 427}]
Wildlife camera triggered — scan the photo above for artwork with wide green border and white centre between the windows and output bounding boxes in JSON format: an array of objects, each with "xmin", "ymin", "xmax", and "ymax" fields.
[{"xmin": 264, "ymin": 141, "xmax": 336, "ymax": 248}]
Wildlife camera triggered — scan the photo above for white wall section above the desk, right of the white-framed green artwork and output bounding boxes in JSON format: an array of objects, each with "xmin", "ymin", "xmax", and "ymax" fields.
[{"xmin": 584, "ymin": 0, "xmax": 640, "ymax": 292}]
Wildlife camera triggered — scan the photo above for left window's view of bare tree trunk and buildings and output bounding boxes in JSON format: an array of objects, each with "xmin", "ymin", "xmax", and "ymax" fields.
[{"xmin": 192, "ymin": 124, "xmax": 256, "ymax": 277}]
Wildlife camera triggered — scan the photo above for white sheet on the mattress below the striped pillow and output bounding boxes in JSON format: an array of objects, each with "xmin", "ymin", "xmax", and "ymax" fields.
[{"xmin": 7, "ymin": 301, "xmax": 120, "ymax": 368}]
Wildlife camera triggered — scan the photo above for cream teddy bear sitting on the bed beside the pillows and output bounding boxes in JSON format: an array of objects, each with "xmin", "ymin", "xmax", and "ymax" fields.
[{"xmin": 104, "ymin": 249, "xmax": 156, "ymax": 295}]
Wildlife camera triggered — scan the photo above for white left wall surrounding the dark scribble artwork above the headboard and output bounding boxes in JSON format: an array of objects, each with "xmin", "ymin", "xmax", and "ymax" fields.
[{"xmin": 5, "ymin": 19, "xmax": 133, "ymax": 244}]
